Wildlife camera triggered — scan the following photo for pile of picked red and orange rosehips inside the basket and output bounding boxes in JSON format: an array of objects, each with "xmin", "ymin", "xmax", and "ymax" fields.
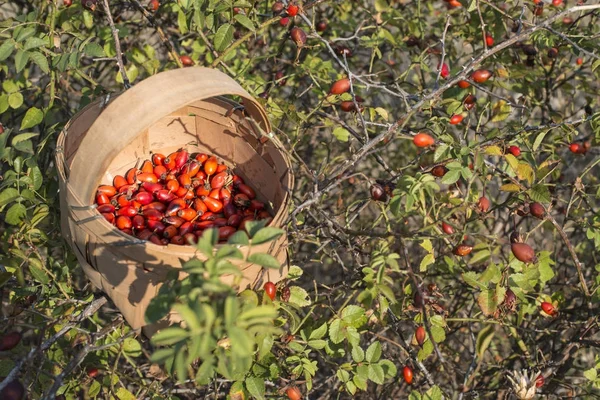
[{"xmin": 96, "ymin": 149, "xmax": 272, "ymax": 245}]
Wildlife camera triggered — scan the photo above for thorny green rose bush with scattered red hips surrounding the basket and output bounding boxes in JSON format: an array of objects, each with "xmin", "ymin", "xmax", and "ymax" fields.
[{"xmin": 0, "ymin": 0, "xmax": 600, "ymax": 399}]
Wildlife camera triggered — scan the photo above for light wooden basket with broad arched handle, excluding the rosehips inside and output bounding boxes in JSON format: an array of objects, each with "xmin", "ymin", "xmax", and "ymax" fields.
[{"xmin": 56, "ymin": 67, "xmax": 293, "ymax": 335}]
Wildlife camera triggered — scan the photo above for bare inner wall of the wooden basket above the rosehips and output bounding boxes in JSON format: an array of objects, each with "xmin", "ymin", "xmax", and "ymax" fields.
[{"xmin": 65, "ymin": 97, "xmax": 290, "ymax": 215}]
